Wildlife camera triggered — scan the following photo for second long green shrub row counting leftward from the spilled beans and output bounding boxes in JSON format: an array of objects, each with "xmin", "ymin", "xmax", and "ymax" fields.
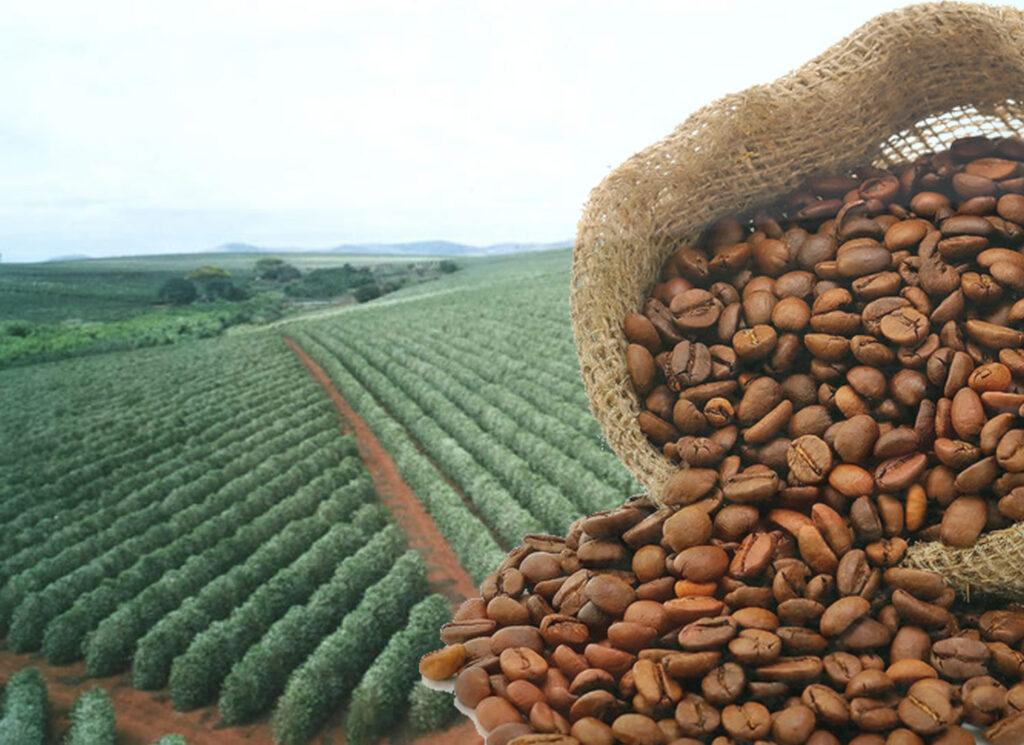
[{"xmin": 273, "ymin": 551, "xmax": 427, "ymax": 745}]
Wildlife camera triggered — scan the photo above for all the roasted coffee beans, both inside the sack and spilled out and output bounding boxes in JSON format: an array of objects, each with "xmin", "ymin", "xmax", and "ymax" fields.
[{"xmin": 420, "ymin": 138, "xmax": 1024, "ymax": 745}]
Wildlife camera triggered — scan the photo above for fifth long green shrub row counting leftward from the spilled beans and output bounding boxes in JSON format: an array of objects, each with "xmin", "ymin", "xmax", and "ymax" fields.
[{"xmin": 132, "ymin": 476, "xmax": 374, "ymax": 690}]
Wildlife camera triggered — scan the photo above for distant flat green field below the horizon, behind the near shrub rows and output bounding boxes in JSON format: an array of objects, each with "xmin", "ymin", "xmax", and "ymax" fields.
[{"xmin": 0, "ymin": 253, "xmax": 456, "ymax": 368}]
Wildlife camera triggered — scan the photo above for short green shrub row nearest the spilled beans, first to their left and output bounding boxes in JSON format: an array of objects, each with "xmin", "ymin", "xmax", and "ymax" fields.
[{"xmin": 345, "ymin": 595, "xmax": 452, "ymax": 745}]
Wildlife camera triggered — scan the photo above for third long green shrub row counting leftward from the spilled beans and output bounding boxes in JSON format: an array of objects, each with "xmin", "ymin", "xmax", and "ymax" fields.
[{"xmin": 218, "ymin": 526, "xmax": 406, "ymax": 725}]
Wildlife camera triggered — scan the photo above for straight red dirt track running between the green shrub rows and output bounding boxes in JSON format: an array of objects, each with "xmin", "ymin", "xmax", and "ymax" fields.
[{"xmin": 285, "ymin": 337, "xmax": 476, "ymax": 603}]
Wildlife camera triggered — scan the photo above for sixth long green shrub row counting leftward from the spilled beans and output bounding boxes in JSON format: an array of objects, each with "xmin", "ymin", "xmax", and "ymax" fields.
[{"xmin": 84, "ymin": 455, "xmax": 362, "ymax": 676}]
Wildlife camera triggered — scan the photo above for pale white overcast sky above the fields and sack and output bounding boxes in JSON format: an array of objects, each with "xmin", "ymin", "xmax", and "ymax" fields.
[{"xmin": 0, "ymin": 0, "xmax": 1024, "ymax": 261}]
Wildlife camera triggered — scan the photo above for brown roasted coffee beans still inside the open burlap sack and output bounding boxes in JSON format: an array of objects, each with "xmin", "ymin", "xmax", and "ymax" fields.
[{"xmin": 624, "ymin": 137, "xmax": 1024, "ymax": 546}]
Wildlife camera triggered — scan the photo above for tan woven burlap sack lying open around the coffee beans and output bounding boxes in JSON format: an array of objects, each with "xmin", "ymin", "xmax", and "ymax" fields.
[{"xmin": 571, "ymin": 3, "xmax": 1024, "ymax": 599}]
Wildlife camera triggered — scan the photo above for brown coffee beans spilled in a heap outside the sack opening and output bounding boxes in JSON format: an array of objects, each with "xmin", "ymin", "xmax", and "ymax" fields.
[{"xmin": 420, "ymin": 495, "xmax": 1024, "ymax": 745}]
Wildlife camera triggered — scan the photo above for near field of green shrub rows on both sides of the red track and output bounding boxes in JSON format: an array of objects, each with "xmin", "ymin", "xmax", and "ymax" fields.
[{"xmin": 0, "ymin": 251, "xmax": 638, "ymax": 742}]
